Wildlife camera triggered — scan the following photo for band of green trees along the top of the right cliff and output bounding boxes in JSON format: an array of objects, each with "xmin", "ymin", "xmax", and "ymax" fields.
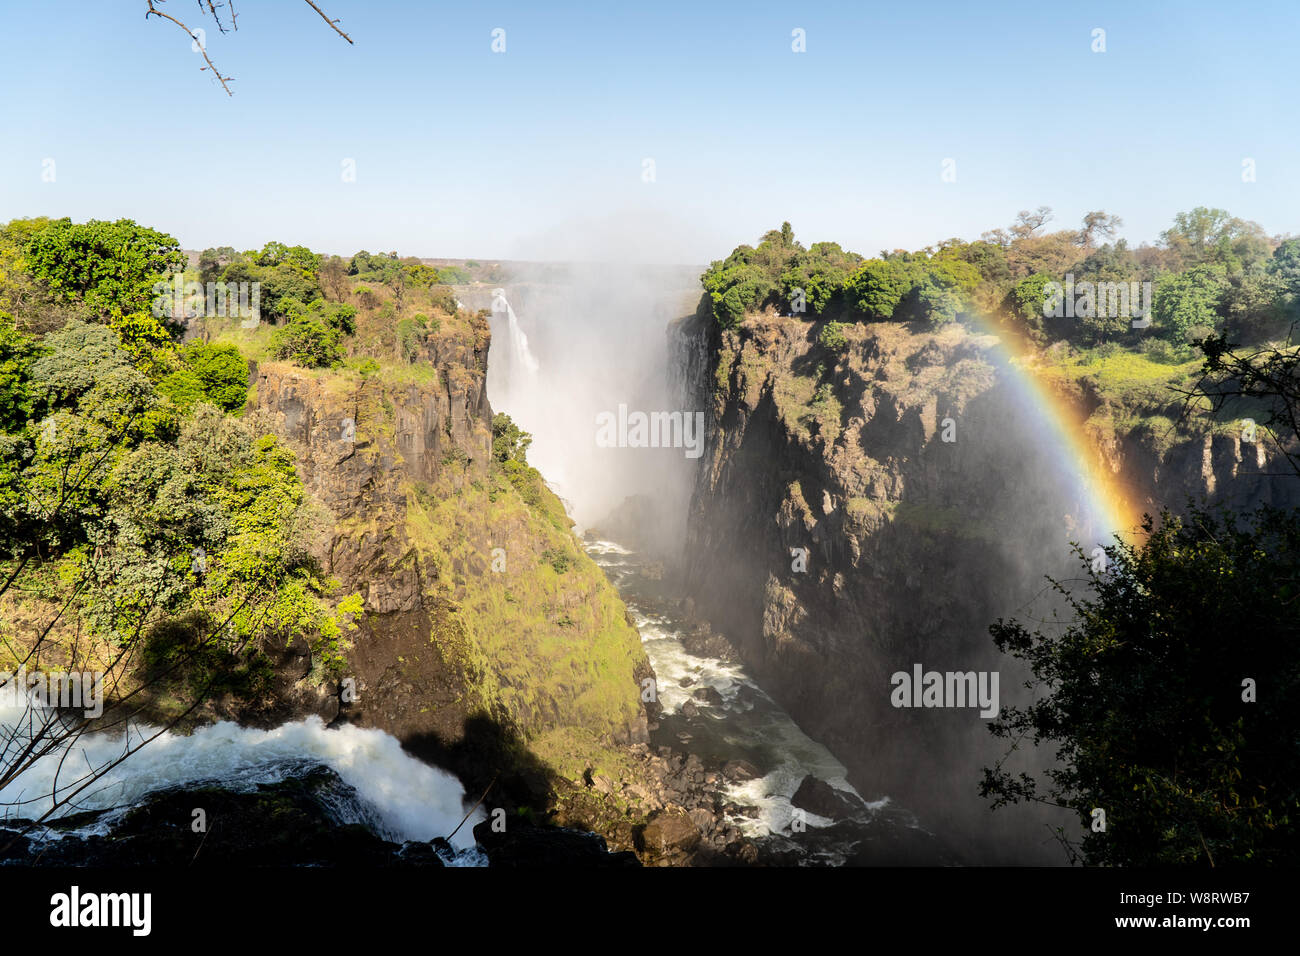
[{"xmin": 702, "ymin": 207, "xmax": 1300, "ymax": 355}]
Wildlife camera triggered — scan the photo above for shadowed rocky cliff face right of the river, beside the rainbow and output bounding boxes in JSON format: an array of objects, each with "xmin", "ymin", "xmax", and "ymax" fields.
[{"xmin": 675, "ymin": 315, "xmax": 1300, "ymax": 860}]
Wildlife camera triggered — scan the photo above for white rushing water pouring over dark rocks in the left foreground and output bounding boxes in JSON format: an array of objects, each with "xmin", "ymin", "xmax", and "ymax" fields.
[{"xmin": 0, "ymin": 706, "xmax": 484, "ymax": 849}]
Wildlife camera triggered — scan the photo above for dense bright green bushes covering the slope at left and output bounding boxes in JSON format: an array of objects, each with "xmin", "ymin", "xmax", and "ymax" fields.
[{"xmin": 0, "ymin": 220, "xmax": 361, "ymax": 691}]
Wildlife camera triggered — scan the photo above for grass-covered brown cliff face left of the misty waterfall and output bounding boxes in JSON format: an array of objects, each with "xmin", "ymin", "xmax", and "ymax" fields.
[{"xmin": 245, "ymin": 320, "xmax": 649, "ymax": 806}]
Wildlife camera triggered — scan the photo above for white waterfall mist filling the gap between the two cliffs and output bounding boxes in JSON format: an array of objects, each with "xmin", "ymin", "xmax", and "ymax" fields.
[{"xmin": 476, "ymin": 261, "xmax": 699, "ymax": 546}]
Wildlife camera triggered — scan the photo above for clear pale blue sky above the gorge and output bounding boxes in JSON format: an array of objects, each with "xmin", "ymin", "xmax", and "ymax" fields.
[{"xmin": 0, "ymin": 0, "xmax": 1300, "ymax": 263}]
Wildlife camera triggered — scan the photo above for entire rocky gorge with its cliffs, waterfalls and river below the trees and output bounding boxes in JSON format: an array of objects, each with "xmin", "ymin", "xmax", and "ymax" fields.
[{"xmin": 0, "ymin": 222, "xmax": 1295, "ymax": 865}]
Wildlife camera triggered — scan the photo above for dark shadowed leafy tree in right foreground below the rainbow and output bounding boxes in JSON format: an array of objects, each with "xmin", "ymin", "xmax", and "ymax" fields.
[{"xmin": 980, "ymin": 507, "xmax": 1300, "ymax": 866}]
